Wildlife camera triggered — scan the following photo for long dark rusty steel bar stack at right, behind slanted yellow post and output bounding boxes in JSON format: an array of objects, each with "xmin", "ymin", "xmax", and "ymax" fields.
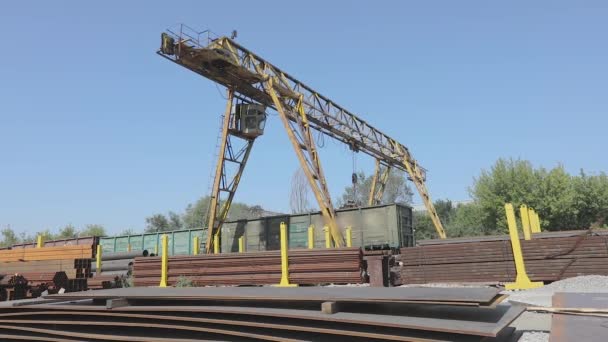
[{"xmin": 391, "ymin": 230, "xmax": 608, "ymax": 285}]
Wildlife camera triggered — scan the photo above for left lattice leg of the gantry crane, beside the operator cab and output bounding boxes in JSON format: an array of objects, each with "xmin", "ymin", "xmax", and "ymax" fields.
[{"xmin": 205, "ymin": 89, "xmax": 255, "ymax": 253}]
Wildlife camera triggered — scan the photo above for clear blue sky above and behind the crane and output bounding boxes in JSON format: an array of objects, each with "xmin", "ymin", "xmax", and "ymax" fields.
[{"xmin": 0, "ymin": 1, "xmax": 608, "ymax": 233}]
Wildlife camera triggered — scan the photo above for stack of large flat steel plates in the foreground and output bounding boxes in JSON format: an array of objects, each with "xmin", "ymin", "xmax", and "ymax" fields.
[{"xmin": 0, "ymin": 287, "xmax": 523, "ymax": 342}]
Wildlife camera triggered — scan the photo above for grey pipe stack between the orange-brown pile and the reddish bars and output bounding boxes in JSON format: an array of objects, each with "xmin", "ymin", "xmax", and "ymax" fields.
[{"xmin": 88, "ymin": 250, "xmax": 149, "ymax": 290}]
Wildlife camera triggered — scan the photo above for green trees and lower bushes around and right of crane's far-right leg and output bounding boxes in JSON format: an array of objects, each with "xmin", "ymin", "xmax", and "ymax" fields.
[{"xmin": 414, "ymin": 159, "xmax": 608, "ymax": 239}]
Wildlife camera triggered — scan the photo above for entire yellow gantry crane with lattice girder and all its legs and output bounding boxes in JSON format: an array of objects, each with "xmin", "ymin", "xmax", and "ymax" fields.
[{"xmin": 157, "ymin": 25, "xmax": 446, "ymax": 253}]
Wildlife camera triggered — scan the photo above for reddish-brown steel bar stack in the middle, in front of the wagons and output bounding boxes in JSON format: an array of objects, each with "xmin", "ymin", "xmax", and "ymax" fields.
[{"xmin": 133, "ymin": 247, "xmax": 365, "ymax": 286}]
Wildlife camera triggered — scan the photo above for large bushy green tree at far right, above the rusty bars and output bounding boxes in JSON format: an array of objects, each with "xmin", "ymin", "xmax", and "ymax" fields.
[{"xmin": 470, "ymin": 159, "xmax": 608, "ymax": 233}]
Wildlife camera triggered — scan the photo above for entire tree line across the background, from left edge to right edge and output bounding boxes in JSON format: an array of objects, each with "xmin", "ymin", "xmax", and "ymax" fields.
[{"xmin": 0, "ymin": 159, "xmax": 608, "ymax": 247}]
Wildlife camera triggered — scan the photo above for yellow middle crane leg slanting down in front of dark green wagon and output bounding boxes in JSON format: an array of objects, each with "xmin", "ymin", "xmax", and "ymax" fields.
[{"xmin": 264, "ymin": 78, "xmax": 344, "ymax": 247}]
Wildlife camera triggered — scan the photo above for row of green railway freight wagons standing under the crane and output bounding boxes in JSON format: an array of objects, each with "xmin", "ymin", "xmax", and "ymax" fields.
[{"xmin": 100, "ymin": 204, "xmax": 415, "ymax": 255}]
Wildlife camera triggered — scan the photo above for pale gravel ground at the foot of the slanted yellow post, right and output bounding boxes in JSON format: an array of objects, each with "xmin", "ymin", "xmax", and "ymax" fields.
[{"xmin": 502, "ymin": 275, "xmax": 608, "ymax": 307}]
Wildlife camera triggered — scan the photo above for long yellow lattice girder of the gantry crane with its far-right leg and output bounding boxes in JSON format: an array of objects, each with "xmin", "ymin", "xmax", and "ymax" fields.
[{"xmin": 158, "ymin": 28, "xmax": 445, "ymax": 238}]
